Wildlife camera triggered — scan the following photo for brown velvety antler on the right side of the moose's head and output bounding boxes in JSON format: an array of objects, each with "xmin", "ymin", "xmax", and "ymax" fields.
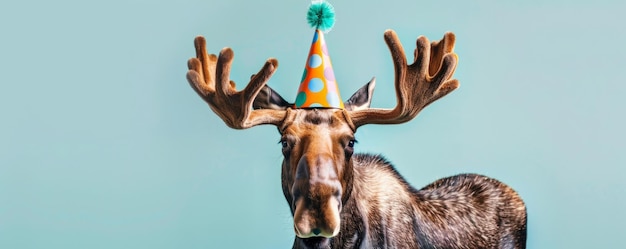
[{"xmin": 349, "ymin": 30, "xmax": 459, "ymax": 128}]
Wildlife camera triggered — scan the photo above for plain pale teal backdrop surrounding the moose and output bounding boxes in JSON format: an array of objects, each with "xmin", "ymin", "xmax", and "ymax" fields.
[{"xmin": 0, "ymin": 0, "xmax": 626, "ymax": 249}]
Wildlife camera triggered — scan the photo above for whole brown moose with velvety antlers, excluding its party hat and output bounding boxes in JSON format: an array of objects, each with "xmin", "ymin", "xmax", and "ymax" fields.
[{"xmin": 187, "ymin": 30, "xmax": 527, "ymax": 249}]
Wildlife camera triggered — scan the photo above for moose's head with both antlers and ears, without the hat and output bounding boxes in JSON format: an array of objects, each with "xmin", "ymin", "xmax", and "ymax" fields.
[{"xmin": 187, "ymin": 30, "xmax": 459, "ymax": 243}]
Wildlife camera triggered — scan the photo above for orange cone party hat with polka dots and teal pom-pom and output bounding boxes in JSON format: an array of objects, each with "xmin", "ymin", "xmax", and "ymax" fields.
[{"xmin": 295, "ymin": 1, "xmax": 344, "ymax": 109}]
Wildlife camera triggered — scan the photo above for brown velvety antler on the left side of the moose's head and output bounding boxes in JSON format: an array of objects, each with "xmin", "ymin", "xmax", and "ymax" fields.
[{"xmin": 187, "ymin": 36, "xmax": 285, "ymax": 129}]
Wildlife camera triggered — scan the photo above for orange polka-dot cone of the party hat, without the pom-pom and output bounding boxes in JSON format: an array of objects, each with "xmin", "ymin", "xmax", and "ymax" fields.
[{"xmin": 295, "ymin": 30, "xmax": 344, "ymax": 109}]
